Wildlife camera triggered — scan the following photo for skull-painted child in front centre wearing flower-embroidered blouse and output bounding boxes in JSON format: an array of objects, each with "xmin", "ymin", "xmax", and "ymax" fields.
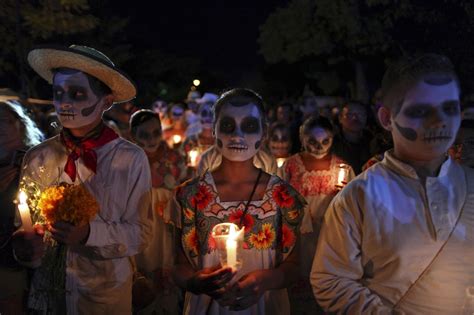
[{"xmin": 174, "ymin": 89, "xmax": 305, "ymax": 314}]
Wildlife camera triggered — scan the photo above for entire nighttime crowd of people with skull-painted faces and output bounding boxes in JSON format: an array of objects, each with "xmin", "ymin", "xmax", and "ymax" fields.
[{"xmin": 0, "ymin": 45, "xmax": 474, "ymax": 314}]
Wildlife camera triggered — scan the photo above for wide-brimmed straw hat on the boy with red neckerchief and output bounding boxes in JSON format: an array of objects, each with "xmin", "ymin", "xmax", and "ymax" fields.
[{"xmin": 28, "ymin": 45, "xmax": 137, "ymax": 103}]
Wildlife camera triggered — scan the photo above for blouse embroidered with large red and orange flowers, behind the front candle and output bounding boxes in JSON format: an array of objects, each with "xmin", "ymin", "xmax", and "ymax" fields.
[{"xmin": 176, "ymin": 172, "xmax": 305, "ymax": 314}]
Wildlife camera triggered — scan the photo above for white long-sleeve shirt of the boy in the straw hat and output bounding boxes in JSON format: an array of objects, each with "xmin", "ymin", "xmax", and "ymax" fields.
[{"xmin": 22, "ymin": 136, "xmax": 152, "ymax": 314}]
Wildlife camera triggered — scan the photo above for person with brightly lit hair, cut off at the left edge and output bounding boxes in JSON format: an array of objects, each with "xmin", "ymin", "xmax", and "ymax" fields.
[{"xmin": 0, "ymin": 100, "xmax": 43, "ymax": 315}]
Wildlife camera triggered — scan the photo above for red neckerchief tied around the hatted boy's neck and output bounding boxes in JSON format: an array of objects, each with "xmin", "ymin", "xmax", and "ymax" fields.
[{"xmin": 60, "ymin": 124, "xmax": 118, "ymax": 182}]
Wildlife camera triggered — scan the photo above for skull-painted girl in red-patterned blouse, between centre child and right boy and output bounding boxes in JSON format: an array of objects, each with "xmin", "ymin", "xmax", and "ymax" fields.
[{"xmin": 282, "ymin": 116, "xmax": 355, "ymax": 314}]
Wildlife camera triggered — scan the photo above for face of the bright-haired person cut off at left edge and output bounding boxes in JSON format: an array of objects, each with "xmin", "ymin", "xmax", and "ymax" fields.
[{"xmin": 0, "ymin": 105, "xmax": 23, "ymax": 160}]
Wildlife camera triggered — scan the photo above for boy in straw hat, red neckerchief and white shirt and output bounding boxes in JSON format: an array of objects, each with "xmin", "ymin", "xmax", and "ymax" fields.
[{"xmin": 15, "ymin": 45, "xmax": 151, "ymax": 314}]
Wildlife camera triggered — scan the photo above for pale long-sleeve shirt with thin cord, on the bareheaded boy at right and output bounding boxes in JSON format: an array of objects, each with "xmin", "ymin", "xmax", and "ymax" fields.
[{"xmin": 311, "ymin": 151, "xmax": 474, "ymax": 314}]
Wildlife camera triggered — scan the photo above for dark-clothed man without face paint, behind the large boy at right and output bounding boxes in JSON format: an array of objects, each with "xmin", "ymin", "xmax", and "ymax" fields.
[{"xmin": 333, "ymin": 101, "xmax": 372, "ymax": 175}]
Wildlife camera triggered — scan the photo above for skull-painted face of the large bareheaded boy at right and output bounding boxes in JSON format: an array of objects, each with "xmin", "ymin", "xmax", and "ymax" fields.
[{"xmin": 391, "ymin": 80, "xmax": 461, "ymax": 161}]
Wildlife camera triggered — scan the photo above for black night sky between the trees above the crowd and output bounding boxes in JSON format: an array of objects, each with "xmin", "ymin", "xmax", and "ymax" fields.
[{"xmin": 110, "ymin": 0, "xmax": 286, "ymax": 82}]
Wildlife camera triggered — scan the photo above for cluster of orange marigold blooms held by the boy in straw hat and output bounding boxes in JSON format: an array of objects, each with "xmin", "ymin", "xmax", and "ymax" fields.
[{"xmin": 38, "ymin": 184, "xmax": 99, "ymax": 226}]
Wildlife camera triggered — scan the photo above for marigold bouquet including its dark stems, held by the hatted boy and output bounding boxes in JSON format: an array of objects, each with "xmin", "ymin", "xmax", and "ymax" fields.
[{"xmin": 35, "ymin": 183, "xmax": 99, "ymax": 310}]
